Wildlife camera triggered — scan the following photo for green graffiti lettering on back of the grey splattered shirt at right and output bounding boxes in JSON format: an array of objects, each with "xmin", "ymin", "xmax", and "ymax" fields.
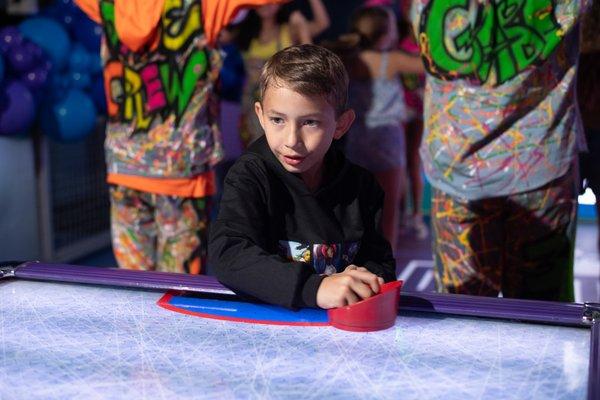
[{"xmin": 420, "ymin": 0, "xmax": 562, "ymax": 84}]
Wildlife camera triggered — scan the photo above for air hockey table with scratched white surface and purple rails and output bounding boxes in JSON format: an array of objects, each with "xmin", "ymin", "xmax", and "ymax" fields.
[{"xmin": 0, "ymin": 263, "xmax": 600, "ymax": 400}]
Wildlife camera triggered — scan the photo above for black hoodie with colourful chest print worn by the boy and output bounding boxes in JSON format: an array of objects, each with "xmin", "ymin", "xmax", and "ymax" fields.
[{"xmin": 209, "ymin": 136, "xmax": 396, "ymax": 308}]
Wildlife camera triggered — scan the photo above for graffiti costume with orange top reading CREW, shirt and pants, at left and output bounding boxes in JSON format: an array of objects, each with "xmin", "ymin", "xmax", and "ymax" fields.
[{"xmin": 77, "ymin": 0, "xmax": 284, "ymax": 272}]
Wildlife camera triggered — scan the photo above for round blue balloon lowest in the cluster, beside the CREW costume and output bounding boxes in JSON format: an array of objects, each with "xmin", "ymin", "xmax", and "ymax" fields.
[{"xmin": 42, "ymin": 89, "xmax": 97, "ymax": 142}]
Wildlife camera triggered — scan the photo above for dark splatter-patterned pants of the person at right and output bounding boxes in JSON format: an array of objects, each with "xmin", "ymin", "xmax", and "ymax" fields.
[{"xmin": 431, "ymin": 172, "xmax": 577, "ymax": 301}]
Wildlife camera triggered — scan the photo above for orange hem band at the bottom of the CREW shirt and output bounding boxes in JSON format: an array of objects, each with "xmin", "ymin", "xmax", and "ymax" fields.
[{"xmin": 106, "ymin": 171, "xmax": 216, "ymax": 198}]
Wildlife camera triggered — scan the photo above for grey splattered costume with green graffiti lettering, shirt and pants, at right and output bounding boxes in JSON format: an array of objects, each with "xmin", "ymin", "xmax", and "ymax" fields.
[{"xmin": 412, "ymin": 0, "xmax": 586, "ymax": 300}]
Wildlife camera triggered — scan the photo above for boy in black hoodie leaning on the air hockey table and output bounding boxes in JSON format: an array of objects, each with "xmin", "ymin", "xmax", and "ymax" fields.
[{"xmin": 209, "ymin": 45, "xmax": 395, "ymax": 308}]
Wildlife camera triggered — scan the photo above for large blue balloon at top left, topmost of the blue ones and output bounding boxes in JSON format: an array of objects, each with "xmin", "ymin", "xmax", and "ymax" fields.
[{"xmin": 19, "ymin": 17, "xmax": 71, "ymax": 70}]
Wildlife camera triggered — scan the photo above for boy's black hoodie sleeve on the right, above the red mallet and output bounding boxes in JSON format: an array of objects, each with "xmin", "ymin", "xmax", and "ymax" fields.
[{"xmin": 354, "ymin": 176, "xmax": 396, "ymax": 282}]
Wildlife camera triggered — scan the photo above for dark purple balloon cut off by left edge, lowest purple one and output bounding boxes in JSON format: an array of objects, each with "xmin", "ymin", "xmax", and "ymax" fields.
[{"xmin": 0, "ymin": 81, "xmax": 35, "ymax": 135}]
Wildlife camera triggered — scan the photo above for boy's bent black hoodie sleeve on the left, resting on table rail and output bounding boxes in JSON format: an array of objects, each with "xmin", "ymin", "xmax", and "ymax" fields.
[{"xmin": 209, "ymin": 157, "xmax": 323, "ymax": 309}]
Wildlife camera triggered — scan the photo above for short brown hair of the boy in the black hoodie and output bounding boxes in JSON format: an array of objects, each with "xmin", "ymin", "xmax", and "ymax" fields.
[{"xmin": 259, "ymin": 44, "xmax": 348, "ymax": 116}]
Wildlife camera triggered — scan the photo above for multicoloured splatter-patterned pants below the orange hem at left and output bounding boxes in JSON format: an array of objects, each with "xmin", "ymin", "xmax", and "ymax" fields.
[{"xmin": 110, "ymin": 186, "xmax": 210, "ymax": 274}]
